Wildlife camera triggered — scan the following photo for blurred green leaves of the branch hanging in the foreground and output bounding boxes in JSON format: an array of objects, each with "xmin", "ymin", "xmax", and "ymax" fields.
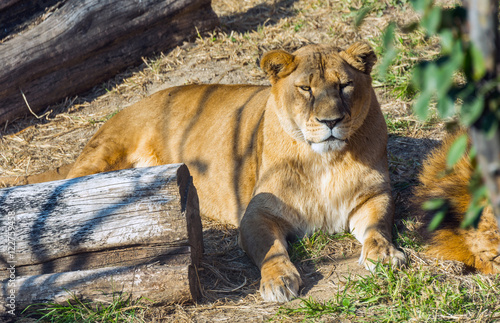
[{"xmin": 379, "ymin": 0, "xmax": 500, "ymax": 228}]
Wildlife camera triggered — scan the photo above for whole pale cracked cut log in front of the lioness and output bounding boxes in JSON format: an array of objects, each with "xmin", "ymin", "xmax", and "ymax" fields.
[{"xmin": 0, "ymin": 164, "xmax": 203, "ymax": 313}]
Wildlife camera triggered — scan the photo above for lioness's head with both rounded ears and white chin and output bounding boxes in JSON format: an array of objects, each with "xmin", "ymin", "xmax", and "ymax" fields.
[{"xmin": 261, "ymin": 42, "xmax": 377, "ymax": 153}]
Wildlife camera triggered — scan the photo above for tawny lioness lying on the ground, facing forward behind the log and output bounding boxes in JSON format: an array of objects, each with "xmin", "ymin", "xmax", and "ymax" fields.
[{"xmin": 6, "ymin": 43, "xmax": 405, "ymax": 302}]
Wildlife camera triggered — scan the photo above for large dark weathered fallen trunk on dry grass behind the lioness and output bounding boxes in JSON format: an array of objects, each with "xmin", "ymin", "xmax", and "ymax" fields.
[{"xmin": 0, "ymin": 0, "xmax": 218, "ymax": 124}]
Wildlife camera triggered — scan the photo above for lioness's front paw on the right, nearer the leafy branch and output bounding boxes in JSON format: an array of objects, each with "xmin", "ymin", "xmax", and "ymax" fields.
[{"xmin": 359, "ymin": 238, "xmax": 406, "ymax": 271}]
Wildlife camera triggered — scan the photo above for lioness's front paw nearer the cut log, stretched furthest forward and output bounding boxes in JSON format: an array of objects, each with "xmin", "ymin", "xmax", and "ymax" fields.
[{"xmin": 260, "ymin": 257, "xmax": 302, "ymax": 302}]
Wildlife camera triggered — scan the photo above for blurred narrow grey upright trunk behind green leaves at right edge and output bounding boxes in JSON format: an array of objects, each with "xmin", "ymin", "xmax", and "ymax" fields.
[{"xmin": 467, "ymin": 0, "xmax": 500, "ymax": 228}]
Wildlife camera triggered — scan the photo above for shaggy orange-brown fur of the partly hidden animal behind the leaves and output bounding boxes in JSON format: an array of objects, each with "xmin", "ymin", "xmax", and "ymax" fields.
[{"xmin": 415, "ymin": 135, "xmax": 500, "ymax": 274}]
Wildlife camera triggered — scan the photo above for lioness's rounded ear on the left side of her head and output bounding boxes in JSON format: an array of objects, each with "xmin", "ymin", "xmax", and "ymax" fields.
[{"xmin": 260, "ymin": 50, "xmax": 295, "ymax": 84}]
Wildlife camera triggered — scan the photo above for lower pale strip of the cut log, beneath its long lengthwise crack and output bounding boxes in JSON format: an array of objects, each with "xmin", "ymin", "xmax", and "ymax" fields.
[{"xmin": 8, "ymin": 263, "xmax": 193, "ymax": 312}]
